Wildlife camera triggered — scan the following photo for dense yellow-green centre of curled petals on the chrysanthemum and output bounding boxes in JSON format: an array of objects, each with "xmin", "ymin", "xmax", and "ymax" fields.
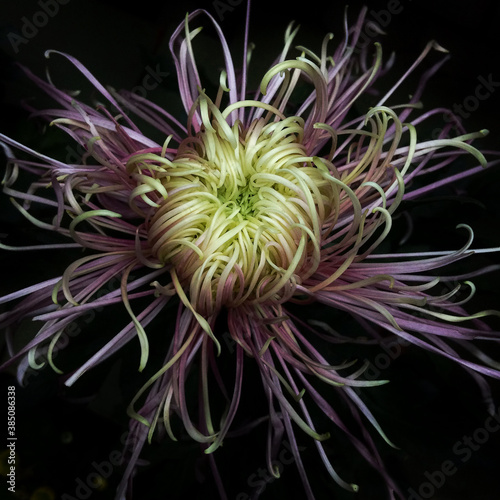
[{"xmin": 129, "ymin": 109, "xmax": 339, "ymax": 314}]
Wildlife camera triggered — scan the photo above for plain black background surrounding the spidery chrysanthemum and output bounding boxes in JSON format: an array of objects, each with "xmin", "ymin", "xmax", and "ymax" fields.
[{"xmin": 0, "ymin": 0, "xmax": 500, "ymax": 500}]
